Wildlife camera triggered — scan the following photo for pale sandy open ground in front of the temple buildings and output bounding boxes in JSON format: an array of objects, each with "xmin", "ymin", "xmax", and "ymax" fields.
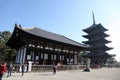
[{"xmin": 3, "ymin": 68, "xmax": 120, "ymax": 80}]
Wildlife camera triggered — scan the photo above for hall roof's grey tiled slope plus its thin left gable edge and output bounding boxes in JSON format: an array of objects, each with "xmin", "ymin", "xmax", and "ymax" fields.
[{"xmin": 7, "ymin": 26, "xmax": 87, "ymax": 48}]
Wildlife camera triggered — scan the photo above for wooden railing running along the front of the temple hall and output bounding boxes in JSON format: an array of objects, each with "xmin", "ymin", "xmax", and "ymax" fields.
[{"xmin": 13, "ymin": 65, "xmax": 84, "ymax": 72}]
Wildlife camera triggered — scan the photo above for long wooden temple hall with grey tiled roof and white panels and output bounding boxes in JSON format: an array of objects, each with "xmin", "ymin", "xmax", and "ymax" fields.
[{"xmin": 6, "ymin": 24, "xmax": 87, "ymax": 65}]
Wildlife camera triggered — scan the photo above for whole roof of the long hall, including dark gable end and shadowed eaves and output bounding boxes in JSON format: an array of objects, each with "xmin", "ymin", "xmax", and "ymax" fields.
[{"xmin": 6, "ymin": 24, "xmax": 87, "ymax": 48}]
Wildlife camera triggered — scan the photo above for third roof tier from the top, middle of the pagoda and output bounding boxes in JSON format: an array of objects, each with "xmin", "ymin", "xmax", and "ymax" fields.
[{"xmin": 83, "ymin": 37, "xmax": 111, "ymax": 45}]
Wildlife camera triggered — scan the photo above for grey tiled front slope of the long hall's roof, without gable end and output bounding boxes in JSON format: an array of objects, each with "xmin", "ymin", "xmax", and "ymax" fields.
[{"xmin": 20, "ymin": 27, "xmax": 86, "ymax": 47}]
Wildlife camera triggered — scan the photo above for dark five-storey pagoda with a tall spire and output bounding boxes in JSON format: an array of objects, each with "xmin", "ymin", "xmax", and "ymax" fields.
[{"xmin": 83, "ymin": 14, "xmax": 113, "ymax": 64}]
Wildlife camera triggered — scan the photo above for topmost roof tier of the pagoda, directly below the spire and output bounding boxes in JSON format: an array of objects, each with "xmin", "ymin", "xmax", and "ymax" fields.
[{"xmin": 83, "ymin": 24, "xmax": 108, "ymax": 34}]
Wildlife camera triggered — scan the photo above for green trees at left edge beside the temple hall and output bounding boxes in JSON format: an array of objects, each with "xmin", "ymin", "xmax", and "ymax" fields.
[{"xmin": 0, "ymin": 31, "xmax": 16, "ymax": 61}]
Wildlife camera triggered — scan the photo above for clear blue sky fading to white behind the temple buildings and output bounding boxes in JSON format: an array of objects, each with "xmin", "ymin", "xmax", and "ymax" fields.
[{"xmin": 0, "ymin": 0, "xmax": 120, "ymax": 61}]
